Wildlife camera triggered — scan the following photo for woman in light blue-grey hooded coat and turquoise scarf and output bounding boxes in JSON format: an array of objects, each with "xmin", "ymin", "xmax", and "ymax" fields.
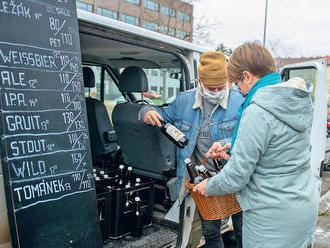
[{"xmin": 194, "ymin": 43, "xmax": 318, "ymax": 248}]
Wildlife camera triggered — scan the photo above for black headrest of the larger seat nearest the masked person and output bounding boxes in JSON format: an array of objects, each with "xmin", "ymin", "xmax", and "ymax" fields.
[{"xmin": 119, "ymin": 66, "xmax": 149, "ymax": 92}]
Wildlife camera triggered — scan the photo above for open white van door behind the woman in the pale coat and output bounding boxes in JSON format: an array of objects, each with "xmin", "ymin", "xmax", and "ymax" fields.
[{"xmin": 281, "ymin": 60, "xmax": 327, "ymax": 198}]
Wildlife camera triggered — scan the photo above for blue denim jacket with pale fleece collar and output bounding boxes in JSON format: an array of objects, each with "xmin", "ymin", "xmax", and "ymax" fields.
[{"xmin": 159, "ymin": 88, "xmax": 244, "ymax": 189}]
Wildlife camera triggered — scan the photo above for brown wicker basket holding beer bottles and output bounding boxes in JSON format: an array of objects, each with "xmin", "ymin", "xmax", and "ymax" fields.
[{"xmin": 185, "ymin": 159, "xmax": 242, "ymax": 220}]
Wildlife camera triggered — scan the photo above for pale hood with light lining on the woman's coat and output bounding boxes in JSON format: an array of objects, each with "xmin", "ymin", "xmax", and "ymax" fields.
[{"xmin": 251, "ymin": 78, "xmax": 313, "ymax": 132}]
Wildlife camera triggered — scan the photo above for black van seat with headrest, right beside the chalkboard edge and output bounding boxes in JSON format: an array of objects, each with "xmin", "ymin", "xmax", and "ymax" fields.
[{"xmin": 83, "ymin": 67, "xmax": 117, "ymax": 166}]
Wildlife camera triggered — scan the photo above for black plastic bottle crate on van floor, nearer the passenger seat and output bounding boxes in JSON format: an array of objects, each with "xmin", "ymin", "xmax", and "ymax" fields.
[{"xmin": 110, "ymin": 182, "xmax": 154, "ymax": 239}]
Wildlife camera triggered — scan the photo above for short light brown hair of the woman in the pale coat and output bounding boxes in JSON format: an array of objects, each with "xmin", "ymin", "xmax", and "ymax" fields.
[{"xmin": 227, "ymin": 43, "xmax": 276, "ymax": 82}]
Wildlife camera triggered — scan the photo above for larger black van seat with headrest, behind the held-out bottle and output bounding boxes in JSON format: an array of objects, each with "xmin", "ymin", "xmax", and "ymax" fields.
[{"xmin": 112, "ymin": 66, "xmax": 176, "ymax": 180}]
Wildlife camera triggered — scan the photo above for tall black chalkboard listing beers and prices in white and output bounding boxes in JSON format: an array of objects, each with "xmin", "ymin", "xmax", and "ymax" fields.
[{"xmin": 0, "ymin": 0, "xmax": 102, "ymax": 248}]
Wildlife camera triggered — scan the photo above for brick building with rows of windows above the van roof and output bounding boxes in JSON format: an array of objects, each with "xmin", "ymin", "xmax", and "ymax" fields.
[{"xmin": 76, "ymin": 0, "xmax": 193, "ymax": 42}]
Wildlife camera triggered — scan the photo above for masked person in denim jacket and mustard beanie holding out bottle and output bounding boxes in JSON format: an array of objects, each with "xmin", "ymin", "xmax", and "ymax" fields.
[{"xmin": 139, "ymin": 52, "xmax": 243, "ymax": 248}]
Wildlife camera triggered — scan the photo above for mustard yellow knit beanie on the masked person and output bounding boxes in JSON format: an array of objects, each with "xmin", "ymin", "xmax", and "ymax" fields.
[{"xmin": 198, "ymin": 51, "xmax": 228, "ymax": 85}]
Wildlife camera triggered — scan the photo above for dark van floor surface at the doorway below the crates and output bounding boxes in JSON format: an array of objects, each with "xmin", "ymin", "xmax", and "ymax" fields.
[{"xmin": 103, "ymin": 224, "xmax": 177, "ymax": 248}]
